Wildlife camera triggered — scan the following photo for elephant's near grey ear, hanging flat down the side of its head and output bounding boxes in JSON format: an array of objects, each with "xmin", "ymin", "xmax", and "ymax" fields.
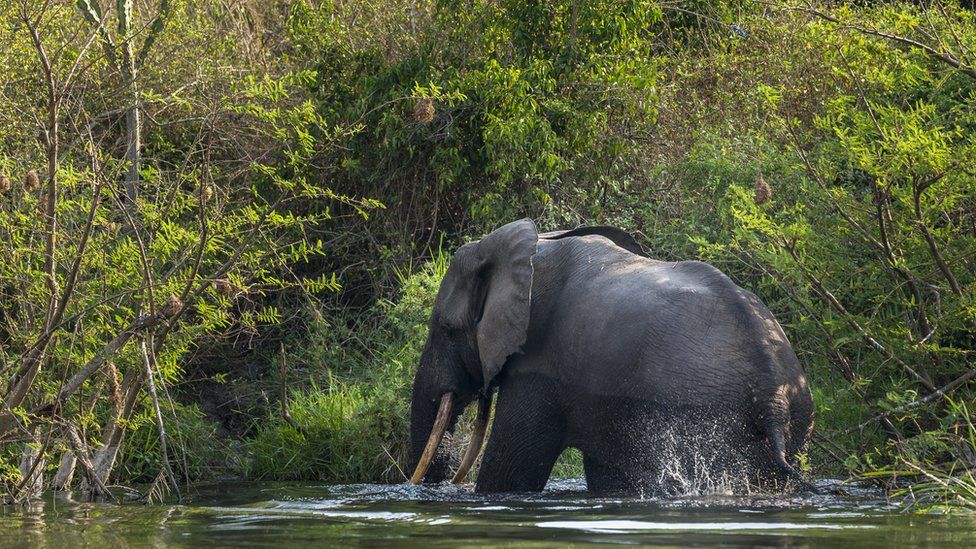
[{"xmin": 477, "ymin": 218, "xmax": 539, "ymax": 389}]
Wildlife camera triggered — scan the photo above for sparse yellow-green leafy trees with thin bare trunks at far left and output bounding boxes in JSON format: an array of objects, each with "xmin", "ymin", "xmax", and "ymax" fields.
[{"xmin": 0, "ymin": 0, "xmax": 381, "ymax": 496}]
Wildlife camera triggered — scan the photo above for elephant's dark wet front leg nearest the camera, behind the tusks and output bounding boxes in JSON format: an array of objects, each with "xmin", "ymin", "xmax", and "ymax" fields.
[{"xmin": 476, "ymin": 376, "xmax": 565, "ymax": 492}]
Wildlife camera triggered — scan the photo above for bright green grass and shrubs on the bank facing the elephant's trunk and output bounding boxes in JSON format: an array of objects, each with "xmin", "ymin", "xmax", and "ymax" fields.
[{"xmin": 241, "ymin": 254, "xmax": 447, "ymax": 482}]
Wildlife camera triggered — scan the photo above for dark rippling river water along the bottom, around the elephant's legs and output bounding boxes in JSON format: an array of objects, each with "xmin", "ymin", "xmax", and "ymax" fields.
[{"xmin": 0, "ymin": 480, "xmax": 976, "ymax": 548}]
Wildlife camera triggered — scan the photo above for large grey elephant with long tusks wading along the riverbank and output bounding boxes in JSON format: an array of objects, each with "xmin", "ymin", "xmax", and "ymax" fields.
[{"xmin": 410, "ymin": 218, "xmax": 813, "ymax": 494}]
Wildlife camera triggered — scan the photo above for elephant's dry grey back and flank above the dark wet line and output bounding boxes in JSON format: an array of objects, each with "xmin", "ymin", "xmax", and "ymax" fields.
[{"xmin": 540, "ymin": 239, "xmax": 805, "ymax": 408}]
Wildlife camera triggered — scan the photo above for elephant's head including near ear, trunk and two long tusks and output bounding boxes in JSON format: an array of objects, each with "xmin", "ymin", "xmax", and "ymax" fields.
[{"xmin": 410, "ymin": 219, "xmax": 539, "ymax": 483}]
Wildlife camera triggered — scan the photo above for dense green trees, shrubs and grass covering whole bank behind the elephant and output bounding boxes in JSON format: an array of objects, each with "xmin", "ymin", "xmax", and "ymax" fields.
[{"xmin": 0, "ymin": 0, "xmax": 976, "ymax": 509}]
